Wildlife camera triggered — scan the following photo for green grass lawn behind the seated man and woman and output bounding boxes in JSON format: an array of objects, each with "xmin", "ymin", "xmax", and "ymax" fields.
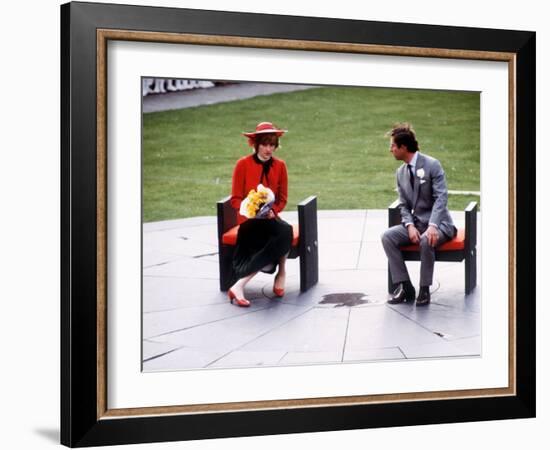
[{"xmin": 143, "ymin": 87, "xmax": 480, "ymax": 222}]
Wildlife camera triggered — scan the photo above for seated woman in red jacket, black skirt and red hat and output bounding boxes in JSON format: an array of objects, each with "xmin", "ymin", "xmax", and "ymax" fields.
[{"xmin": 228, "ymin": 122, "xmax": 292, "ymax": 306}]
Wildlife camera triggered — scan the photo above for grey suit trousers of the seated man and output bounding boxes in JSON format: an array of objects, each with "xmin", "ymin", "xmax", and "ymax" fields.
[{"xmin": 382, "ymin": 225, "xmax": 451, "ymax": 286}]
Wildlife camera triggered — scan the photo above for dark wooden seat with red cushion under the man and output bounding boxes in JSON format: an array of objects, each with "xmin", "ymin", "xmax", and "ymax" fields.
[{"xmin": 388, "ymin": 200, "xmax": 477, "ymax": 295}]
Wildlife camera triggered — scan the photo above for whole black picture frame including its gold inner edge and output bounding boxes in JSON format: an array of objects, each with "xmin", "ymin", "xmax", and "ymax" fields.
[{"xmin": 61, "ymin": 2, "xmax": 536, "ymax": 447}]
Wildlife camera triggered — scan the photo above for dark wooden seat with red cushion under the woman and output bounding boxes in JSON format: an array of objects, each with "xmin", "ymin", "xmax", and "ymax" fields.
[{"xmin": 217, "ymin": 196, "xmax": 319, "ymax": 292}]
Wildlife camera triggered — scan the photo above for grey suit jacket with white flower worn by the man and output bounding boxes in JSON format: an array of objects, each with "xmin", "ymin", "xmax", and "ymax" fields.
[{"xmin": 396, "ymin": 152, "xmax": 456, "ymax": 238}]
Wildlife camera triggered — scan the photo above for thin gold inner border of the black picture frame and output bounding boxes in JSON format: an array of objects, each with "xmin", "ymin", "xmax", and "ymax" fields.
[{"xmin": 97, "ymin": 29, "xmax": 516, "ymax": 420}]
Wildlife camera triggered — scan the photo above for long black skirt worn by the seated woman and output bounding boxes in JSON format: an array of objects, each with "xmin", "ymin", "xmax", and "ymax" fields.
[{"xmin": 233, "ymin": 217, "xmax": 292, "ymax": 279}]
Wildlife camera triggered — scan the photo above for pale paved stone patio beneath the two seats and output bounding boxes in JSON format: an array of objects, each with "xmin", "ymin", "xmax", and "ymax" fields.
[{"xmin": 143, "ymin": 210, "xmax": 481, "ymax": 372}]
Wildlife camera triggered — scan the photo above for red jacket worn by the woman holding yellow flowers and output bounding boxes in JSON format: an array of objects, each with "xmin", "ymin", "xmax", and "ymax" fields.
[{"xmin": 231, "ymin": 155, "xmax": 288, "ymax": 224}]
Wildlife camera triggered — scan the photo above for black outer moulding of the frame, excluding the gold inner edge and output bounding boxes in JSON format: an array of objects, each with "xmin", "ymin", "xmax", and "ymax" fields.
[{"xmin": 61, "ymin": 3, "xmax": 536, "ymax": 447}]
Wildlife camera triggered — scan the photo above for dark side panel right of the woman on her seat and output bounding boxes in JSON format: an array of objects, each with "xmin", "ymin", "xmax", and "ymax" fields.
[{"xmin": 298, "ymin": 197, "xmax": 319, "ymax": 292}]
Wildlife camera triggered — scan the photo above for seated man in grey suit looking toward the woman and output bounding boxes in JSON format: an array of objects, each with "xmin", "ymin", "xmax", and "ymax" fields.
[{"xmin": 382, "ymin": 124, "xmax": 456, "ymax": 306}]
